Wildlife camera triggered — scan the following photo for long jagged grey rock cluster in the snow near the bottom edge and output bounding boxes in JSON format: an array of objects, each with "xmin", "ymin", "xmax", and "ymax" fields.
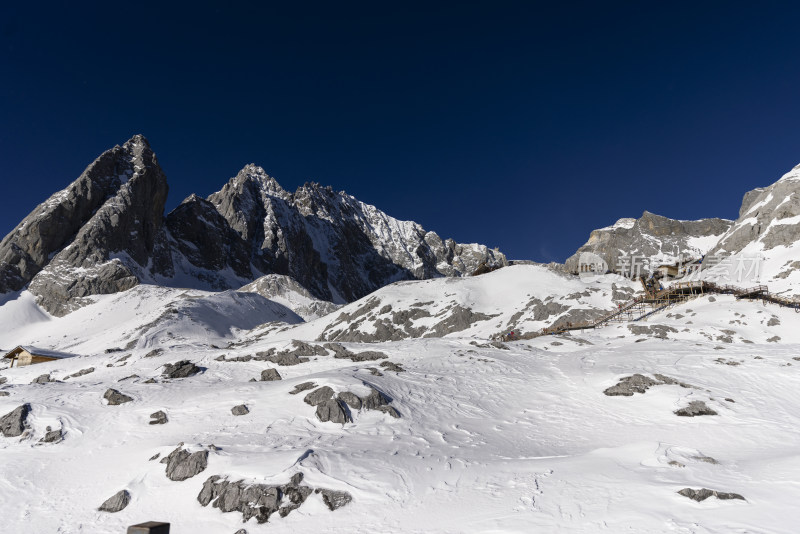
[{"xmin": 197, "ymin": 473, "xmax": 353, "ymax": 523}]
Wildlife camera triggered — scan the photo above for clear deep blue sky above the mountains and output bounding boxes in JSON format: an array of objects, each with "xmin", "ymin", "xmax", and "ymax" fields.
[{"xmin": 0, "ymin": 1, "xmax": 800, "ymax": 261}]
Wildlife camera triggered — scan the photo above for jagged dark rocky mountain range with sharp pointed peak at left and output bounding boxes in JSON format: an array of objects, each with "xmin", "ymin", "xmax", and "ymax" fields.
[{"xmin": 0, "ymin": 135, "xmax": 506, "ymax": 316}]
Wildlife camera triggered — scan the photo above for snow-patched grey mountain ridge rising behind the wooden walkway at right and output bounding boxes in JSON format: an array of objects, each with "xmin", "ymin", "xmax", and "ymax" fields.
[{"xmin": 565, "ymin": 166, "xmax": 800, "ymax": 297}]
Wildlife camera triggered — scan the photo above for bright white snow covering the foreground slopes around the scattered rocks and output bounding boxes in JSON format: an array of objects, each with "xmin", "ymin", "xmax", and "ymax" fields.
[{"xmin": 0, "ymin": 266, "xmax": 800, "ymax": 534}]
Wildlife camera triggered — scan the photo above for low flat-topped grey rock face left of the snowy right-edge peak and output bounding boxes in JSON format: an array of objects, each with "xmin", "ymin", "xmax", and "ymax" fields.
[{"xmin": 565, "ymin": 211, "xmax": 733, "ymax": 273}]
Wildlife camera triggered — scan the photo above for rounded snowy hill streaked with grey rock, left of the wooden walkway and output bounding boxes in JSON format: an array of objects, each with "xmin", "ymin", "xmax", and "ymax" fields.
[{"xmin": 260, "ymin": 265, "xmax": 637, "ymax": 342}]
